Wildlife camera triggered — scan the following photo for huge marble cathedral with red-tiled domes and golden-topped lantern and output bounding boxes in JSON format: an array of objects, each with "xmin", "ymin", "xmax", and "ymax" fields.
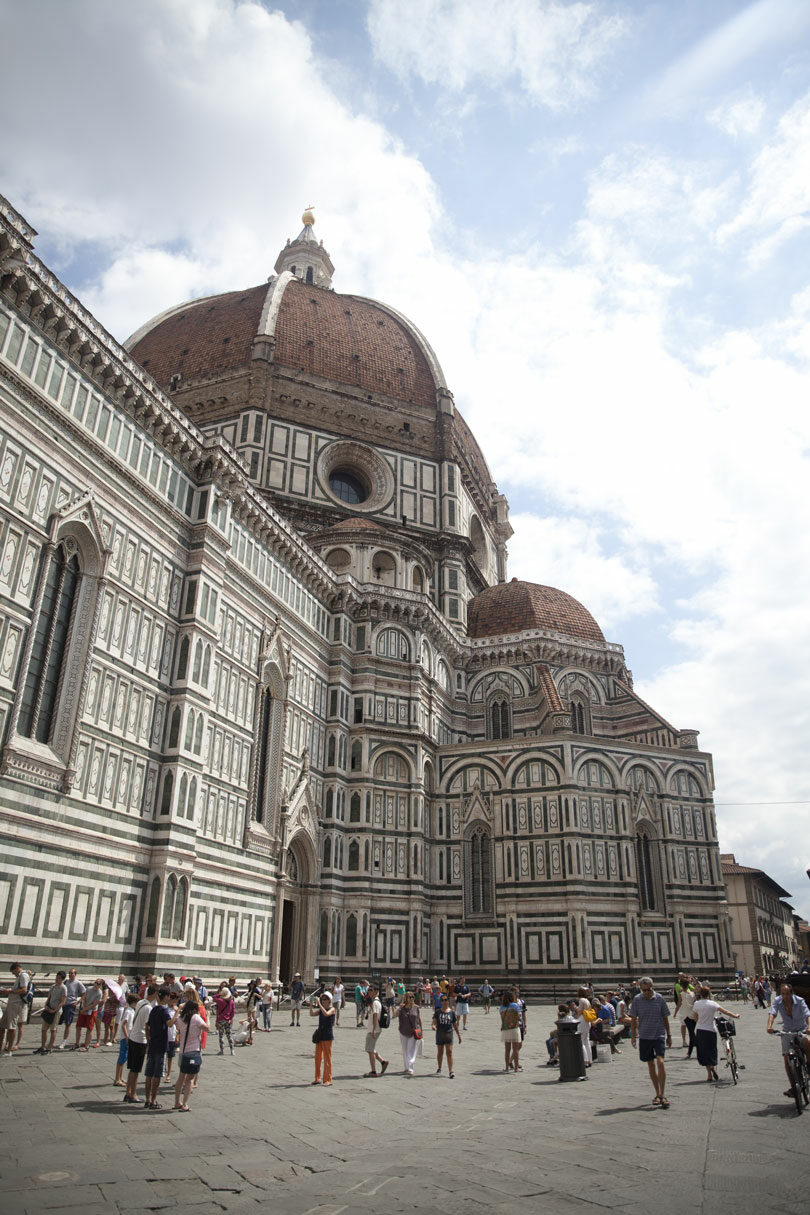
[{"xmin": 0, "ymin": 199, "xmax": 733, "ymax": 991}]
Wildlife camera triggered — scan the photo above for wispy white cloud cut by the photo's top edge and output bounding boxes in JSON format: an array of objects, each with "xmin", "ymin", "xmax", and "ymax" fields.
[{"xmin": 368, "ymin": 0, "xmax": 625, "ymax": 109}]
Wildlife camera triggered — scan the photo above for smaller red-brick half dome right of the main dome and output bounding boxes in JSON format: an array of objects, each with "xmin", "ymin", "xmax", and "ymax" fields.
[{"xmin": 466, "ymin": 578, "xmax": 605, "ymax": 643}]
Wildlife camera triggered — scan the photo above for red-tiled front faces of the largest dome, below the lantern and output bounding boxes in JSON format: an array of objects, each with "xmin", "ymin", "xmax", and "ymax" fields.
[{"xmin": 126, "ymin": 275, "xmax": 443, "ymax": 412}]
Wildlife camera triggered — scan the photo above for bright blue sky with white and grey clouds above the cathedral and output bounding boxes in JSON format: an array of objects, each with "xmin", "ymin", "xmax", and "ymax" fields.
[{"xmin": 0, "ymin": 0, "xmax": 810, "ymax": 916}]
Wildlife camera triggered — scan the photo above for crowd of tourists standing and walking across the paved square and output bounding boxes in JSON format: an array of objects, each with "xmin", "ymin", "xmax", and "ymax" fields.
[{"xmin": 0, "ymin": 962, "xmax": 810, "ymax": 1112}]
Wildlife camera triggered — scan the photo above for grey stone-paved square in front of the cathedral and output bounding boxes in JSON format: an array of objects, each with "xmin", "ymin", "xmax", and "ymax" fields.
[{"xmin": 0, "ymin": 1006, "xmax": 810, "ymax": 1215}]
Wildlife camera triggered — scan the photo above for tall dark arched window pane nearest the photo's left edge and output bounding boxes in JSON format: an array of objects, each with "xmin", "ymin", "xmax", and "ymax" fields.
[{"xmin": 17, "ymin": 544, "xmax": 81, "ymax": 742}]
